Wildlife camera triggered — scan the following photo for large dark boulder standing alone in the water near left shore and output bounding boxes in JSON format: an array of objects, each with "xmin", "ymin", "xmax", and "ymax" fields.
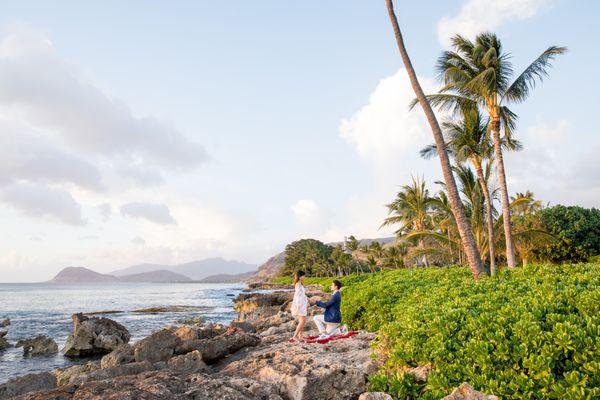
[{"xmin": 64, "ymin": 314, "xmax": 131, "ymax": 357}]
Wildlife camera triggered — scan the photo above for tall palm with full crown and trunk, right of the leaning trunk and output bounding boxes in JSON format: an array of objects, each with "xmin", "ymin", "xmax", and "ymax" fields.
[{"xmin": 422, "ymin": 33, "xmax": 567, "ymax": 268}]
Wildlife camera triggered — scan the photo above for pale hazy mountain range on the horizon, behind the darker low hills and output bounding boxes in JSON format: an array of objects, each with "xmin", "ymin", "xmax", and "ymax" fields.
[{"xmin": 111, "ymin": 257, "xmax": 256, "ymax": 281}]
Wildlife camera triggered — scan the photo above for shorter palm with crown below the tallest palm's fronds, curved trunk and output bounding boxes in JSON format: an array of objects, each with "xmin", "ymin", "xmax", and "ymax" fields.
[{"xmin": 421, "ymin": 108, "xmax": 521, "ymax": 275}]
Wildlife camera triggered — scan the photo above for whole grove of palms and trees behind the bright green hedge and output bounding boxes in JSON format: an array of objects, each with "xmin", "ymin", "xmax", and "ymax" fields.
[{"xmin": 282, "ymin": 25, "xmax": 600, "ymax": 279}]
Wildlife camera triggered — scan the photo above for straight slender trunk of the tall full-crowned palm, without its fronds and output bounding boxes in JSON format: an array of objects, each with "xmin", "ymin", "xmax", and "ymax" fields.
[{"xmin": 491, "ymin": 119, "xmax": 517, "ymax": 268}]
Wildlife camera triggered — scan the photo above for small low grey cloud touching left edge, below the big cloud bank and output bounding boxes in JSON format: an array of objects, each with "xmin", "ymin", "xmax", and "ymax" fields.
[{"xmin": 0, "ymin": 183, "xmax": 86, "ymax": 225}]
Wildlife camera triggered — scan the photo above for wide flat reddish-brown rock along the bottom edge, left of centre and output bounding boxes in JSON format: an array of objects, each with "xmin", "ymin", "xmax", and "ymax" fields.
[{"xmin": 19, "ymin": 369, "xmax": 283, "ymax": 400}]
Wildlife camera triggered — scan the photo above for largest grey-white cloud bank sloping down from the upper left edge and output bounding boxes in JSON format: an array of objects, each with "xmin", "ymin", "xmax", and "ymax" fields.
[{"xmin": 0, "ymin": 27, "xmax": 207, "ymax": 168}]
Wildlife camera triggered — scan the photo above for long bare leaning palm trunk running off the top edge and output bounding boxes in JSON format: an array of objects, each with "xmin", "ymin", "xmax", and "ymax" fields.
[{"xmin": 386, "ymin": 0, "xmax": 485, "ymax": 279}]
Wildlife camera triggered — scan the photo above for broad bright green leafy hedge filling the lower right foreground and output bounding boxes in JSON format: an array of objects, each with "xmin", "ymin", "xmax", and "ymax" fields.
[{"xmin": 342, "ymin": 264, "xmax": 600, "ymax": 400}]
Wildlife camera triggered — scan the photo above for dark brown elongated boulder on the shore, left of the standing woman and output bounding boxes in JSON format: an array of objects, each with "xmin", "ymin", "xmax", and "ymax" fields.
[{"xmin": 176, "ymin": 330, "xmax": 260, "ymax": 364}]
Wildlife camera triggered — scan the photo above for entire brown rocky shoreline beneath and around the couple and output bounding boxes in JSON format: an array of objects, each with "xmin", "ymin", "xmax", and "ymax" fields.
[{"xmin": 0, "ymin": 285, "xmax": 494, "ymax": 400}]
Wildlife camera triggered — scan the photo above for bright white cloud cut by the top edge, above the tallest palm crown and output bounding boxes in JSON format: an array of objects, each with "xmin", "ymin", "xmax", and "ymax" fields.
[{"xmin": 437, "ymin": 0, "xmax": 549, "ymax": 47}]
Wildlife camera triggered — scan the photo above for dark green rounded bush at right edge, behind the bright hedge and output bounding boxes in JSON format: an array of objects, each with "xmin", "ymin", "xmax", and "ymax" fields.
[{"xmin": 538, "ymin": 205, "xmax": 600, "ymax": 262}]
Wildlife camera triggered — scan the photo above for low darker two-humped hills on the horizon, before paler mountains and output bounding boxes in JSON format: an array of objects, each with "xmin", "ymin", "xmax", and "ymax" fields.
[{"xmin": 50, "ymin": 267, "xmax": 192, "ymax": 283}]
